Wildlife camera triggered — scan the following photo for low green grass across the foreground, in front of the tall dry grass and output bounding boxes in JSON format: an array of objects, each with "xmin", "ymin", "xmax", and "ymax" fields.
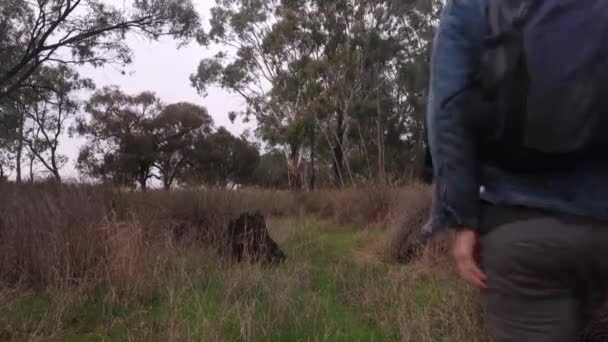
[{"xmin": 0, "ymin": 219, "xmax": 484, "ymax": 341}]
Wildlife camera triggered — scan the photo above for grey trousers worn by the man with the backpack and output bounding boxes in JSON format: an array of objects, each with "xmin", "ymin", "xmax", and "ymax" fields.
[{"xmin": 480, "ymin": 206, "xmax": 608, "ymax": 342}]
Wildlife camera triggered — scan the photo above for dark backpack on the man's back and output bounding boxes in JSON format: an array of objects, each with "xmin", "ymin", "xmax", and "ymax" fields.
[{"xmin": 476, "ymin": 0, "xmax": 608, "ymax": 171}]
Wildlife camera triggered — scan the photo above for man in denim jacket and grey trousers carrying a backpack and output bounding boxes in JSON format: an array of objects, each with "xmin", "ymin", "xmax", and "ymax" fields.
[{"xmin": 427, "ymin": 0, "xmax": 608, "ymax": 342}]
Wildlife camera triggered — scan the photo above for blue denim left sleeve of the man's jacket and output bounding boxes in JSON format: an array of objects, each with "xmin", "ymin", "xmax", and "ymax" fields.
[{"xmin": 427, "ymin": 0, "xmax": 486, "ymax": 234}]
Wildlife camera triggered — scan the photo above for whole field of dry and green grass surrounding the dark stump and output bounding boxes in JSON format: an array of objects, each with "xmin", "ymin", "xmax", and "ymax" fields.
[{"xmin": 0, "ymin": 180, "xmax": 494, "ymax": 341}]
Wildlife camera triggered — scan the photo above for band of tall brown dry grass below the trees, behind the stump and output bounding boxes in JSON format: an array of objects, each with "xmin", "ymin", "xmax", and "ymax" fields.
[{"xmin": 0, "ymin": 184, "xmax": 429, "ymax": 287}]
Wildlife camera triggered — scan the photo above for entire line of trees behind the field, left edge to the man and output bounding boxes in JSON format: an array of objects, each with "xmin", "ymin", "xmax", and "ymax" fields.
[{"xmin": 0, "ymin": 0, "xmax": 442, "ymax": 189}]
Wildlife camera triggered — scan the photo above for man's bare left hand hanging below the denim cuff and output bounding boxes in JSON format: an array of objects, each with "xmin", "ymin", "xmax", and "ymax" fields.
[{"xmin": 452, "ymin": 229, "xmax": 487, "ymax": 289}]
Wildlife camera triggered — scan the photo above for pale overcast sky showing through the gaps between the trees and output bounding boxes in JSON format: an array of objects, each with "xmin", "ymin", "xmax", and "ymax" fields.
[{"xmin": 61, "ymin": 0, "xmax": 251, "ymax": 178}]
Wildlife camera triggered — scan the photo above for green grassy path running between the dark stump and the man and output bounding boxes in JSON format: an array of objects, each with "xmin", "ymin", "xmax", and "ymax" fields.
[{"xmin": 273, "ymin": 224, "xmax": 393, "ymax": 341}]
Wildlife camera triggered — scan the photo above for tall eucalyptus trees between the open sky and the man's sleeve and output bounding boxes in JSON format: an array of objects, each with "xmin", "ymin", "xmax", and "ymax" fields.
[{"xmin": 197, "ymin": 0, "xmax": 442, "ymax": 186}]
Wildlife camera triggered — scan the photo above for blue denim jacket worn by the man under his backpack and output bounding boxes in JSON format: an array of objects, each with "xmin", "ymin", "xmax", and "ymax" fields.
[{"xmin": 424, "ymin": 0, "xmax": 608, "ymax": 234}]
